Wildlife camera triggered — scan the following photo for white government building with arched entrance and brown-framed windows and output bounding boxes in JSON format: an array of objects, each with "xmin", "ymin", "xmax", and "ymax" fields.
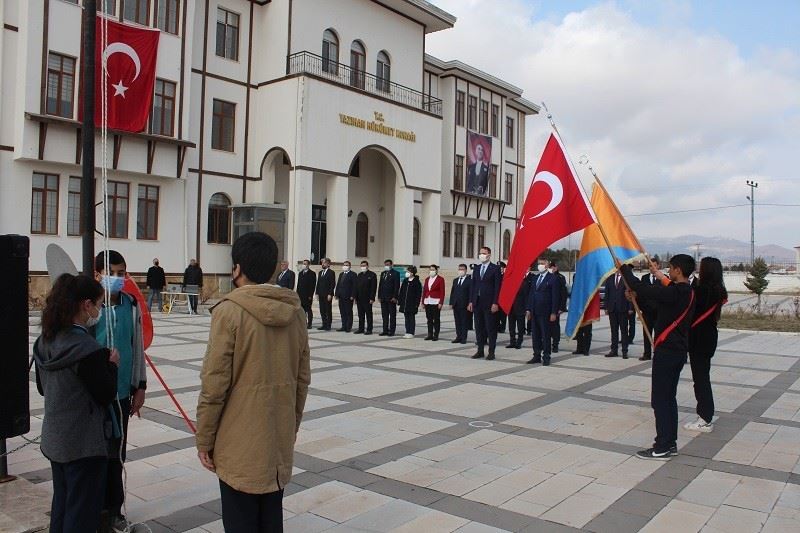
[{"xmin": 0, "ymin": 0, "xmax": 538, "ymax": 282}]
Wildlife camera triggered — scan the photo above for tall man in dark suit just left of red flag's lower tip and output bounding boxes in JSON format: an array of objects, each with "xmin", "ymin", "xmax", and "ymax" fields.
[{"xmin": 467, "ymin": 246, "xmax": 500, "ymax": 361}]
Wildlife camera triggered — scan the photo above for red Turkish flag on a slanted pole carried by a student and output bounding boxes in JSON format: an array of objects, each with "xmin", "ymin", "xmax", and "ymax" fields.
[{"xmin": 498, "ymin": 133, "xmax": 595, "ymax": 312}]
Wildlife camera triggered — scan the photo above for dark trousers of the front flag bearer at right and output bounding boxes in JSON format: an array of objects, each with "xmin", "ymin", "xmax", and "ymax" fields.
[{"xmin": 650, "ymin": 348, "xmax": 686, "ymax": 452}]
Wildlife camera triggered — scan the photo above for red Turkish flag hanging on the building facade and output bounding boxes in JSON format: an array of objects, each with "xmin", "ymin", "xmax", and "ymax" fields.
[{"xmin": 94, "ymin": 16, "xmax": 161, "ymax": 132}]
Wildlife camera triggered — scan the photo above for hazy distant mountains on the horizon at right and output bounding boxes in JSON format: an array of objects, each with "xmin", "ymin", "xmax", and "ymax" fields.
[{"xmin": 639, "ymin": 235, "xmax": 796, "ymax": 263}]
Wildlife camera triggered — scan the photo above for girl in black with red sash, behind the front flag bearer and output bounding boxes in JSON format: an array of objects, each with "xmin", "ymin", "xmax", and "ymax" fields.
[{"xmin": 683, "ymin": 257, "xmax": 728, "ymax": 433}]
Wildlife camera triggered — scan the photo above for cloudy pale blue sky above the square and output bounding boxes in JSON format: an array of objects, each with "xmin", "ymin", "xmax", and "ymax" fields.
[{"xmin": 426, "ymin": 0, "xmax": 800, "ymax": 247}]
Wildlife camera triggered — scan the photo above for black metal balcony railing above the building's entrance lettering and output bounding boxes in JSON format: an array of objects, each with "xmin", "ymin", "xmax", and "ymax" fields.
[{"xmin": 287, "ymin": 52, "xmax": 442, "ymax": 117}]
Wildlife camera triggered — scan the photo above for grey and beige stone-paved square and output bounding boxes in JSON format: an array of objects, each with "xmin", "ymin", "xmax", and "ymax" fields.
[{"xmin": 6, "ymin": 306, "xmax": 800, "ymax": 533}]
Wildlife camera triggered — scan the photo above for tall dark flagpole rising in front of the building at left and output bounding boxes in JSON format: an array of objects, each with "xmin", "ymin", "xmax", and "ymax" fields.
[{"xmin": 81, "ymin": 0, "xmax": 97, "ymax": 276}]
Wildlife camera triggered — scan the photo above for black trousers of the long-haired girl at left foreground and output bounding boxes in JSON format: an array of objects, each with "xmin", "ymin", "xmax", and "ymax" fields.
[{"xmin": 50, "ymin": 457, "xmax": 108, "ymax": 533}]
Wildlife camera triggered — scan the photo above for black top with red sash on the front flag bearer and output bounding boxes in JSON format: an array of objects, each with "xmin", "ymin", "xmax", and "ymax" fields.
[{"xmin": 620, "ymin": 265, "xmax": 695, "ymax": 355}]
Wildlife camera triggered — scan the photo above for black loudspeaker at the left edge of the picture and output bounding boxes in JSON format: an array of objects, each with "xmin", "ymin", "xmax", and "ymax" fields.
[{"xmin": 0, "ymin": 235, "xmax": 31, "ymax": 439}]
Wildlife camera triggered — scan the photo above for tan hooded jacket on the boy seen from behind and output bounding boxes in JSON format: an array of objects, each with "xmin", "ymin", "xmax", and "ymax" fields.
[{"xmin": 196, "ymin": 285, "xmax": 311, "ymax": 494}]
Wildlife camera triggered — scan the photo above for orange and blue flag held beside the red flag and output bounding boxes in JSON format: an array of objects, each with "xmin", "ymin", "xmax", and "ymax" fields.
[{"xmin": 565, "ymin": 184, "xmax": 644, "ymax": 338}]
